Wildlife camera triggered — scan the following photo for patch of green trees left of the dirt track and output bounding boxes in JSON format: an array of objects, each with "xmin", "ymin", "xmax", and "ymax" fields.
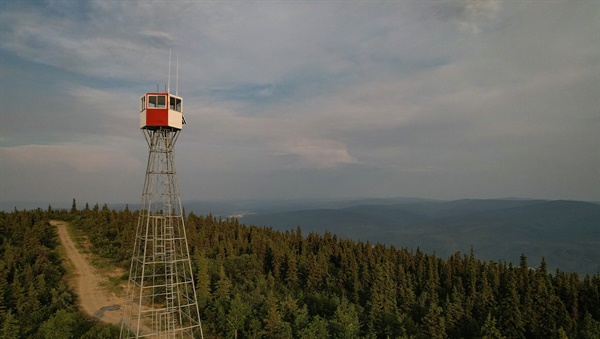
[{"xmin": 0, "ymin": 208, "xmax": 119, "ymax": 338}]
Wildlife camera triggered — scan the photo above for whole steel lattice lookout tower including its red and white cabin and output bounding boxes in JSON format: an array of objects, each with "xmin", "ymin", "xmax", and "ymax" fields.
[{"xmin": 121, "ymin": 92, "xmax": 203, "ymax": 338}]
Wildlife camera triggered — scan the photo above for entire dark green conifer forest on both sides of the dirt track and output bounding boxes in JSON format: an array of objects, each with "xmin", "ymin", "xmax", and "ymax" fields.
[{"xmin": 0, "ymin": 202, "xmax": 600, "ymax": 339}]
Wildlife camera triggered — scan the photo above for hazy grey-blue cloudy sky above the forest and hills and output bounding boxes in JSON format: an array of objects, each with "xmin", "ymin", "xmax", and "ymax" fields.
[{"xmin": 0, "ymin": 0, "xmax": 600, "ymax": 203}]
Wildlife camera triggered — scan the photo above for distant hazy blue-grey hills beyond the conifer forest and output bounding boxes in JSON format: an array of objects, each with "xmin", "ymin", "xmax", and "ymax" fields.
[{"xmin": 240, "ymin": 200, "xmax": 600, "ymax": 274}]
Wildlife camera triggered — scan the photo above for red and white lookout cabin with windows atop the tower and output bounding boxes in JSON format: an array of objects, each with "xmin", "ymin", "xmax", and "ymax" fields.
[{"xmin": 140, "ymin": 92, "xmax": 186, "ymax": 130}]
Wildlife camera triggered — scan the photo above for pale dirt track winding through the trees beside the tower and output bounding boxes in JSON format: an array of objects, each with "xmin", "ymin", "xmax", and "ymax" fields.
[{"xmin": 50, "ymin": 220, "xmax": 123, "ymax": 325}]
